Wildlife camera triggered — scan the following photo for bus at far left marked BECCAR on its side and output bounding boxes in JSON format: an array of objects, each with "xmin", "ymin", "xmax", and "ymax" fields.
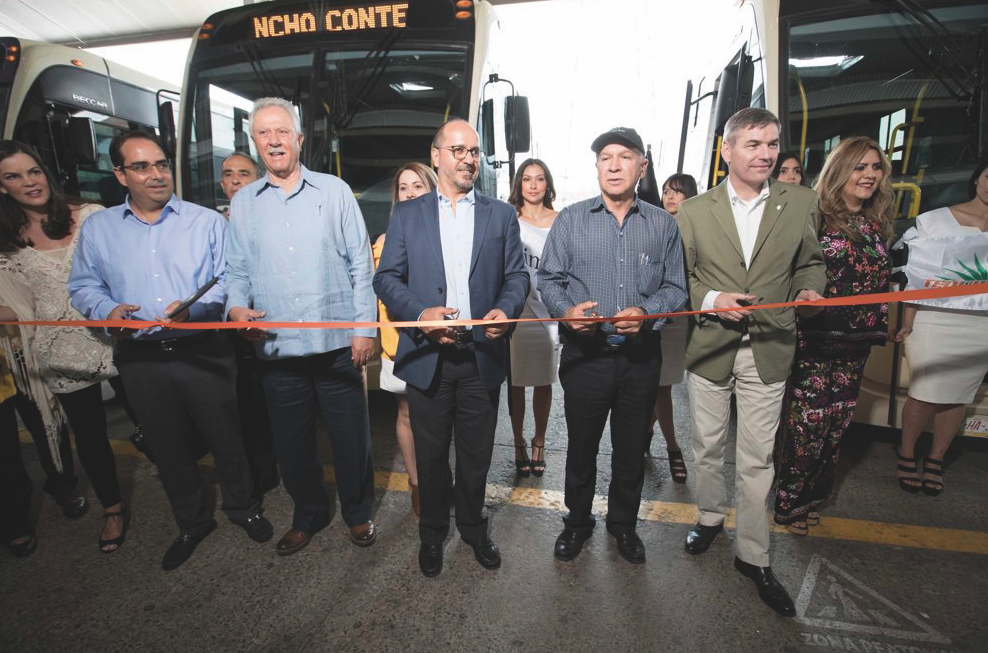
[{"xmin": 0, "ymin": 37, "xmax": 178, "ymax": 206}]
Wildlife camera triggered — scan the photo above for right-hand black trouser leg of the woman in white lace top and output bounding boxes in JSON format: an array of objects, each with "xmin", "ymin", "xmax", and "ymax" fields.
[{"xmin": 55, "ymin": 383, "xmax": 120, "ymax": 508}]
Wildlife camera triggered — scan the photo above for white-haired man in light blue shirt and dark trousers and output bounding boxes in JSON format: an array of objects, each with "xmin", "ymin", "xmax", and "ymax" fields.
[{"xmin": 226, "ymin": 98, "xmax": 377, "ymax": 555}]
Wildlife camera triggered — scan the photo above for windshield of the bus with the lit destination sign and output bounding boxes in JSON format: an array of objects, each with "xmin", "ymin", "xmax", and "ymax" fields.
[{"xmin": 183, "ymin": 43, "xmax": 470, "ymax": 234}]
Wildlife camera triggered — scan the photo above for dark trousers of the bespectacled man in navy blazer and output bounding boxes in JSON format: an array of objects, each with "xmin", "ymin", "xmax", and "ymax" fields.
[{"xmin": 408, "ymin": 346, "xmax": 501, "ymax": 544}]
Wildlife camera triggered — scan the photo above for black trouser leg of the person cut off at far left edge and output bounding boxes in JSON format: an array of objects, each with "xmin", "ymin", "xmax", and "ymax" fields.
[{"xmin": 0, "ymin": 395, "xmax": 33, "ymax": 544}]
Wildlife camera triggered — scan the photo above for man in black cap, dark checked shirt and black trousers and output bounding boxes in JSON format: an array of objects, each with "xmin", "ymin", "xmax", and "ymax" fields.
[{"xmin": 538, "ymin": 127, "xmax": 686, "ymax": 563}]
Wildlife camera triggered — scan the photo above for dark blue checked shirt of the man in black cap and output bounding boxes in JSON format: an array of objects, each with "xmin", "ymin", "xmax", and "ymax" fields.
[{"xmin": 538, "ymin": 196, "xmax": 686, "ymax": 329}]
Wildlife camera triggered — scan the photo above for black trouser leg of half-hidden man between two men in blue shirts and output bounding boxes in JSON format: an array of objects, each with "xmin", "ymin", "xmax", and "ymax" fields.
[{"xmin": 229, "ymin": 331, "xmax": 278, "ymax": 496}]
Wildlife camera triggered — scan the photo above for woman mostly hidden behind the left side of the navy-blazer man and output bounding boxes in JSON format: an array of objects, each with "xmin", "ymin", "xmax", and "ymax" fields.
[{"xmin": 373, "ymin": 162, "xmax": 439, "ymax": 517}]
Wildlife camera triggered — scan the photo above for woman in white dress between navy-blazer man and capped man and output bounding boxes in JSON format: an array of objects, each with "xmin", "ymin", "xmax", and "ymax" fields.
[{"xmin": 508, "ymin": 159, "xmax": 559, "ymax": 476}]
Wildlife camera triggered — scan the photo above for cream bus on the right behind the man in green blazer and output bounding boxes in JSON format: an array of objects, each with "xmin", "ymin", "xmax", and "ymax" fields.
[{"xmin": 678, "ymin": 0, "xmax": 988, "ymax": 437}]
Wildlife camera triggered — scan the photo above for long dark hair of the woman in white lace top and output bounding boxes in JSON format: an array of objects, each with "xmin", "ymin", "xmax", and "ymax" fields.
[{"xmin": 0, "ymin": 141, "xmax": 72, "ymax": 252}]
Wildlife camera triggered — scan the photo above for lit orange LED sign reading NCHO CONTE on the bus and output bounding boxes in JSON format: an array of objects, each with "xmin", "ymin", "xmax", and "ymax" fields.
[{"xmin": 254, "ymin": 2, "xmax": 409, "ymax": 39}]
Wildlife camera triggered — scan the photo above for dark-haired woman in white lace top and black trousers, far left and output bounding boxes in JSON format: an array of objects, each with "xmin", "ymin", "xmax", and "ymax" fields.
[{"xmin": 0, "ymin": 141, "xmax": 126, "ymax": 553}]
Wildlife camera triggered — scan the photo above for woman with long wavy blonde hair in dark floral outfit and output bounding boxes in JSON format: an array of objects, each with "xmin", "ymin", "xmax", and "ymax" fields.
[{"xmin": 775, "ymin": 136, "xmax": 893, "ymax": 535}]
